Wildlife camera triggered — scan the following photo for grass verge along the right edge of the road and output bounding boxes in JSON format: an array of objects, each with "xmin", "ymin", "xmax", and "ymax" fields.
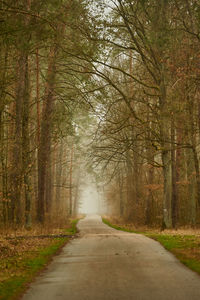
[{"xmin": 102, "ymin": 218, "xmax": 200, "ymax": 274}]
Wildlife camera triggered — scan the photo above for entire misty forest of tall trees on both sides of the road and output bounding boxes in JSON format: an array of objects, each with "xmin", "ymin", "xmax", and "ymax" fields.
[{"xmin": 0, "ymin": 0, "xmax": 200, "ymax": 229}]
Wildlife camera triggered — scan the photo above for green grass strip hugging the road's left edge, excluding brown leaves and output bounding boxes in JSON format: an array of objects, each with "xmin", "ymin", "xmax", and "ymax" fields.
[{"xmin": 0, "ymin": 219, "xmax": 78, "ymax": 300}]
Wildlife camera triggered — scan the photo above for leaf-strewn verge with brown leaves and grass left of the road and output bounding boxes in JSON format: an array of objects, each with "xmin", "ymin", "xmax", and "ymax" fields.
[{"xmin": 0, "ymin": 219, "xmax": 79, "ymax": 300}]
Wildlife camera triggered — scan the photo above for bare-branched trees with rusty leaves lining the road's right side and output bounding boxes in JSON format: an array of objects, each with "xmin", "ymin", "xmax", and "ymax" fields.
[{"xmin": 88, "ymin": 0, "xmax": 200, "ymax": 228}]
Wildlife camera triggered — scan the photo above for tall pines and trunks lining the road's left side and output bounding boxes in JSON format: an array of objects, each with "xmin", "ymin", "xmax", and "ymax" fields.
[{"xmin": 0, "ymin": 0, "xmax": 97, "ymax": 228}]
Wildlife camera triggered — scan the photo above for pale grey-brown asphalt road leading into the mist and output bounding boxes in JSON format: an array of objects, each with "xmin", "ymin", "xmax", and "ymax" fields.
[{"xmin": 23, "ymin": 215, "xmax": 200, "ymax": 300}]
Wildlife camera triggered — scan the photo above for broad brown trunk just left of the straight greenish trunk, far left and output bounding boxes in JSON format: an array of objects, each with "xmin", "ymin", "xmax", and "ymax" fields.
[{"xmin": 10, "ymin": 0, "xmax": 31, "ymax": 224}]
